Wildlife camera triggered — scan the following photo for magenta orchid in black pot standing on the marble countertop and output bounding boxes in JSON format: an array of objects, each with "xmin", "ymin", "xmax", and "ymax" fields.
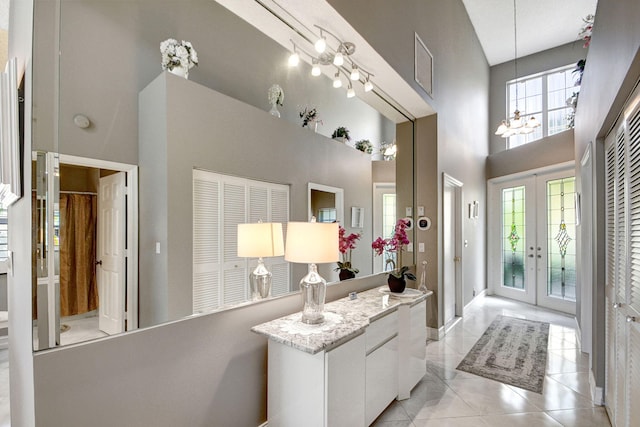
[{"xmin": 371, "ymin": 218, "xmax": 416, "ymax": 293}]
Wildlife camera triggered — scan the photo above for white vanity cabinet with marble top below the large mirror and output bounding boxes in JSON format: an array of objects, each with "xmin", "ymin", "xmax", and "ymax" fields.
[{"xmin": 251, "ymin": 285, "xmax": 432, "ymax": 427}]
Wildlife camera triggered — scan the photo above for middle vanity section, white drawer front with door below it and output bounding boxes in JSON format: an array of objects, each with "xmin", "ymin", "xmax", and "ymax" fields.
[{"xmin": 365, "ymin": 311, "xmax": 398, "ymax": 425}]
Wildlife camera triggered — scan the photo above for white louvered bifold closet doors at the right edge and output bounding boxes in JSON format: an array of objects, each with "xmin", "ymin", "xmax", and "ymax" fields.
[{"xmin": 605, "ymin": 88, "xmax": 640, "ymax": 427}]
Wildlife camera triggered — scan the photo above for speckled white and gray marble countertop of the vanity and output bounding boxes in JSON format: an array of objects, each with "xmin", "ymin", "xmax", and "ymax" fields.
[{"xmin": 251, "ymin": 285, "xmax": 433, "ymax": 354}]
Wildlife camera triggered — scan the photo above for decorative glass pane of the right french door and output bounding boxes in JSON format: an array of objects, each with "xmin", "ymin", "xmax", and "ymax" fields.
[{"xmin": 547, "ymin": 177, "xmax": 576, "ymax": 301}]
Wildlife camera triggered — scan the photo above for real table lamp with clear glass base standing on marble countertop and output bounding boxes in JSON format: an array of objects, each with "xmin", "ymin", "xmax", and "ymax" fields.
[{"xmin": 284, "ymin": 218, "xmax": 339, "ymax": 325}]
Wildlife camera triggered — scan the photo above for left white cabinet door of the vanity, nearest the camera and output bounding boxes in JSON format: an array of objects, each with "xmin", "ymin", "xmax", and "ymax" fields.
[{"xmin": 328, "ymin": 334, "xmax": 365, "ymax": 427}]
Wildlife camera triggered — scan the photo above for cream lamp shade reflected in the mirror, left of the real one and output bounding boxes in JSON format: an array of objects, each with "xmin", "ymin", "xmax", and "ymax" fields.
[{"xmin": 238, "ymin": 222, "xmax": 284, "ymax": 258}]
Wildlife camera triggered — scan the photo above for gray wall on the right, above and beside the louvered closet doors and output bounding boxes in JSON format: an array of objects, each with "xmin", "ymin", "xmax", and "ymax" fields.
[{"xmin": 575, "ymin": 0, "xmax": 640, "ymax": 387}]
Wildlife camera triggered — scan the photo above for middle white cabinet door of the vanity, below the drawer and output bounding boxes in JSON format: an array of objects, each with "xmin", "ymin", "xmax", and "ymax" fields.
[{"xmin": 365, "ymin": 336, "xmax": 398, "ymax": 425}]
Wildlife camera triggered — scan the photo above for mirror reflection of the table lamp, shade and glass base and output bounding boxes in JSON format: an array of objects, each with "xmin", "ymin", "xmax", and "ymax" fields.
[{"xmin": 238, "ymin": 222, "xmax": 284, "ymax": 300}]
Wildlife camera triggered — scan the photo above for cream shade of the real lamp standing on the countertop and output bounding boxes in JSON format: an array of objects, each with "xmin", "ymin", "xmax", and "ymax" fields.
[{"xmin": 284, "ymin": 222, "xmax": 339, "ymax": 264}]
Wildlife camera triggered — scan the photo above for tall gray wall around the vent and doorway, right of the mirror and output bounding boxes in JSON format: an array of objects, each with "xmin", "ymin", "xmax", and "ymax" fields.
[{"xmin": 329, "ymin": 0, "xmax": 490, "ymax": 320}]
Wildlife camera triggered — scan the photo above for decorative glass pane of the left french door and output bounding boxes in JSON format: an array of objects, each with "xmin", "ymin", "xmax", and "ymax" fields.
[{"xmin": 502, "ymin": 186, "xmax": 525, "ymax": 289}]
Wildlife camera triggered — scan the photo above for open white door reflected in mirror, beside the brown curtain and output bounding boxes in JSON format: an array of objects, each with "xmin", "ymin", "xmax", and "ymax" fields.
[{"xmin": 96, "ymin": 172, "xmax": 126, "ymax": 335}]
